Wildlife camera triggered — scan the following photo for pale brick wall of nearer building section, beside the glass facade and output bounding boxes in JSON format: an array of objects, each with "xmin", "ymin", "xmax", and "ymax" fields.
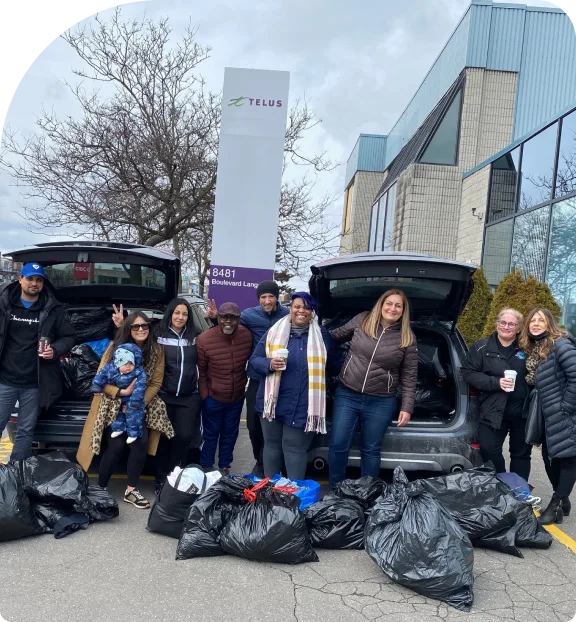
[{"xmin": 394, "ymin": 69, "xmax": 517, "ymax": 263}]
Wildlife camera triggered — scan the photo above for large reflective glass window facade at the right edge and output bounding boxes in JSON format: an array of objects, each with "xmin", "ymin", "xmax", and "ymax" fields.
[{"xmin": 482, "ymin": 109, "xmax": 576, "ymax": 332}]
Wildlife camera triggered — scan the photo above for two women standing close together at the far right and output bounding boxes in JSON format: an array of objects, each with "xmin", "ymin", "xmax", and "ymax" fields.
[{"xmin": 461, "ymin": 308, "xmax": 576, "ymax": 525}]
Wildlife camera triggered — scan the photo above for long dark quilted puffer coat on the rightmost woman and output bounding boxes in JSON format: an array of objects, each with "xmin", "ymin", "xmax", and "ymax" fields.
[{"xmin": 534, "ymin": 338, "xmax": 576, "ymax": 458}]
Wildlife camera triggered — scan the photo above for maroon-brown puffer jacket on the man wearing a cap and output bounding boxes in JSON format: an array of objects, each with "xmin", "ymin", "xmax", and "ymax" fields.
[{"xmin": 196, "ymin": 326, "xmax": 252, "ymax": 404}]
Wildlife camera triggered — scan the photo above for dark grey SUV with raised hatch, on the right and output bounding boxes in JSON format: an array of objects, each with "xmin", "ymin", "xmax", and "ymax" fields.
[{"xmin": 309, "ymin": 253, "xmax": 482, "ymax": 472}]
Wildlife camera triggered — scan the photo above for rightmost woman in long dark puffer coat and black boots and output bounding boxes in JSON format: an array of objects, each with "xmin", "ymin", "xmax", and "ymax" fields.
[{"xmin": 520, "ymin": 308, "xmax": 576, "ymax": 525}]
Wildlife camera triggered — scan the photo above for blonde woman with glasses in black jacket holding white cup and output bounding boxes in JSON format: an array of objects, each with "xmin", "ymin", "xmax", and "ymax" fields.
[{"xmin": 461, "ymin": 309, "xmax": 532, "ymax": 481}]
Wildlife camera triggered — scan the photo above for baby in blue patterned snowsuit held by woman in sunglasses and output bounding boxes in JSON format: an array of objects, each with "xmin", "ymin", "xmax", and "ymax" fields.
[{"xmin": 92, "ymin": 343, "xmax": 146, "ymax": 443}]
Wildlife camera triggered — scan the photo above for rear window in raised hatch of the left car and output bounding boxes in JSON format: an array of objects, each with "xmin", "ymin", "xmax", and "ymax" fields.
[{"xmin": 45, "ymin": 262, "xmax": 166, "ymax": 290}]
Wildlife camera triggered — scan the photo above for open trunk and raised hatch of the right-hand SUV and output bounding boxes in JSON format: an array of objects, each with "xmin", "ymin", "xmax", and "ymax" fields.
[{"xmin": 310, "ymin": 253, "xmax": 475, "ymax": 427}]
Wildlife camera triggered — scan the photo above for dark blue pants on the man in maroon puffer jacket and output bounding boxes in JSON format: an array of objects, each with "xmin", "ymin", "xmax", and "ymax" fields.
[{"xmin": 200, "ymin": 397, "xmax": 244, "ymax": 469}]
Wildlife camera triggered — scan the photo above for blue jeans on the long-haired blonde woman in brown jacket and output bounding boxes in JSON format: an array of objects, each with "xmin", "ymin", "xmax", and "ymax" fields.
[{"xmin": 328, "ymin": 386, "xmax": 397, "ymax": 489}]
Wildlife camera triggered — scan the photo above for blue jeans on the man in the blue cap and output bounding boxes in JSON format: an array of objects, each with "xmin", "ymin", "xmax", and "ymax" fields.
[{"xmin": 0, "ymin": 384, "xmax": 40, "ymax": 460}]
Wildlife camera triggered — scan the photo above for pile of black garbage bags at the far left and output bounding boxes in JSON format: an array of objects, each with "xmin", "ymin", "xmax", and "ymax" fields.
[{"xmin": 0, "ymin": 452, "xmax": 119, "ymax": 541}]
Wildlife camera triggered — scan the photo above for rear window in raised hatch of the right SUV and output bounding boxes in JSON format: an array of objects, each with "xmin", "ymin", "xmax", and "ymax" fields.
[{"xmin": 330, "ymin": 276, "xmax": 453, "ymax": 300}]
